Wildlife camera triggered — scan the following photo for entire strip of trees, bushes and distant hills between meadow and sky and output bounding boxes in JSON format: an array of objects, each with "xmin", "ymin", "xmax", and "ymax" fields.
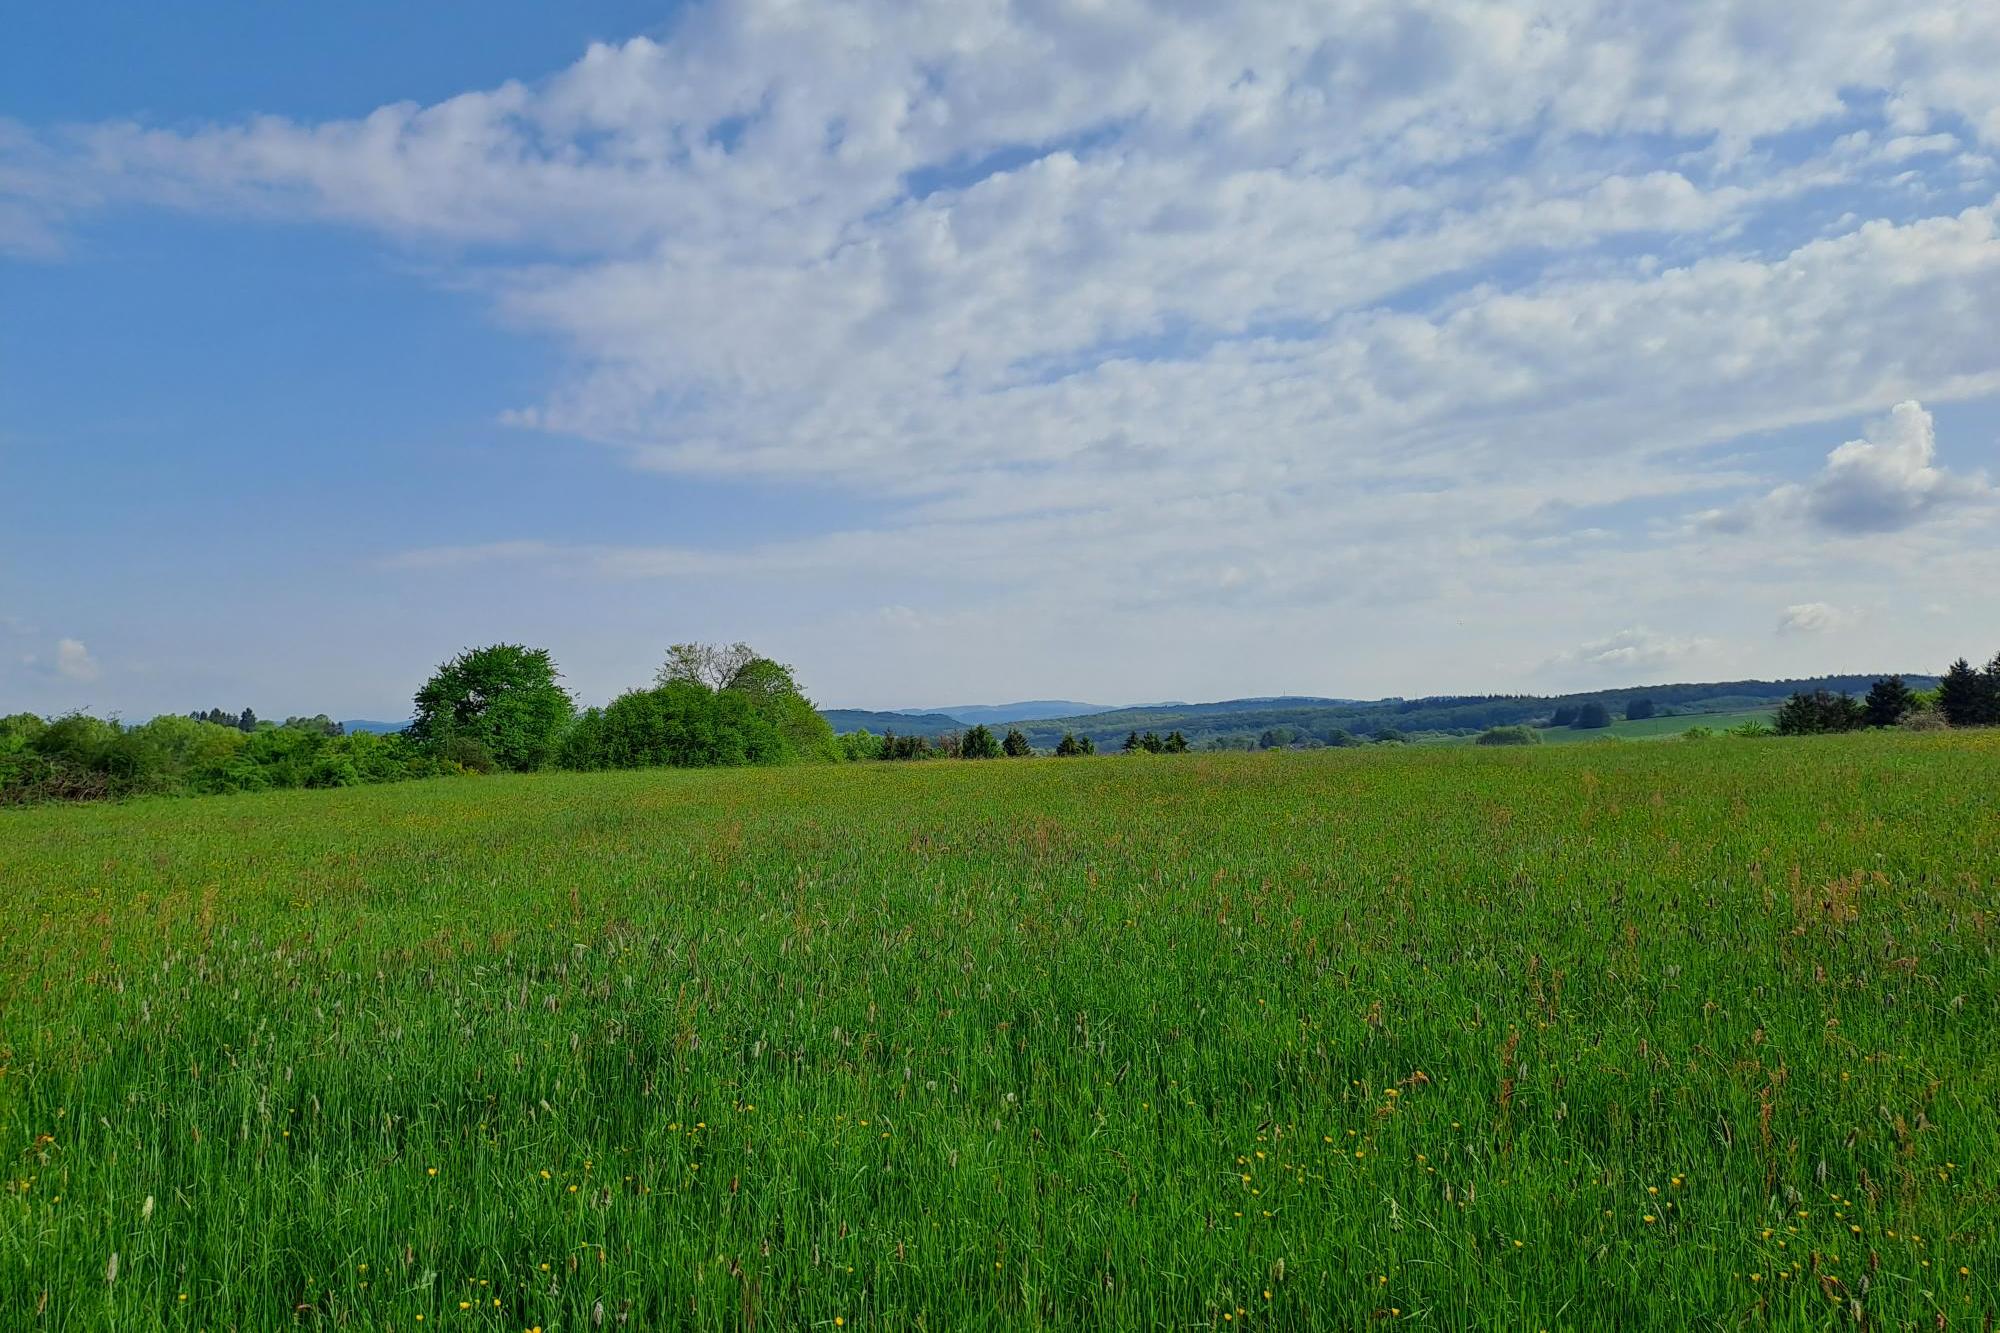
[{"xmin": 0, "ymin": 642, "xmax": 2000, "ymax": 805}]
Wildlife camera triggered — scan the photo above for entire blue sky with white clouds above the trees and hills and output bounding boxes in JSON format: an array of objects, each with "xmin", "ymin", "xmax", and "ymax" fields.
[{"xmin": 0, "ymin": 0, "xmax": 2000, "ymax": 719}]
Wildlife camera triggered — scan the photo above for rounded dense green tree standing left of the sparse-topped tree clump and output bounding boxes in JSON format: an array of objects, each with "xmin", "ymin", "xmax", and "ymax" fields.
[{"xmin": 410, "ymin": 642, "xmax": 576, "ymax": 773}]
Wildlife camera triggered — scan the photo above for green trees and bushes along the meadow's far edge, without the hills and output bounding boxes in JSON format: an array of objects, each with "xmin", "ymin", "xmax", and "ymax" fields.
[{"xmin": 0, "ymin": 642, "xmax": 2000, "ymax": 805}]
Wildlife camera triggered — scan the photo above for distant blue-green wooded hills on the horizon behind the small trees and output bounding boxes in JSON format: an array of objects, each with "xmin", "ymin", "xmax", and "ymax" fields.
[{"xmin": 826, "ymin": 675, "xmax": 1936, "ymax": 751}]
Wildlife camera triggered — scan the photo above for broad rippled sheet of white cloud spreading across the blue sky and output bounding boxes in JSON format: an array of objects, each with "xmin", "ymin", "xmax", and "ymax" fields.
[{"xmin": 0, "ymin": 0, "xmax": 2000, "ymax": 695}]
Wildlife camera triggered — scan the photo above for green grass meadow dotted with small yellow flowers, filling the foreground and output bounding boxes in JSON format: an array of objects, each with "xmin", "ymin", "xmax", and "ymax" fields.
[{"xmin": 0, "ymin": 732, "xmax": 2000, "ymax": 1333}]
